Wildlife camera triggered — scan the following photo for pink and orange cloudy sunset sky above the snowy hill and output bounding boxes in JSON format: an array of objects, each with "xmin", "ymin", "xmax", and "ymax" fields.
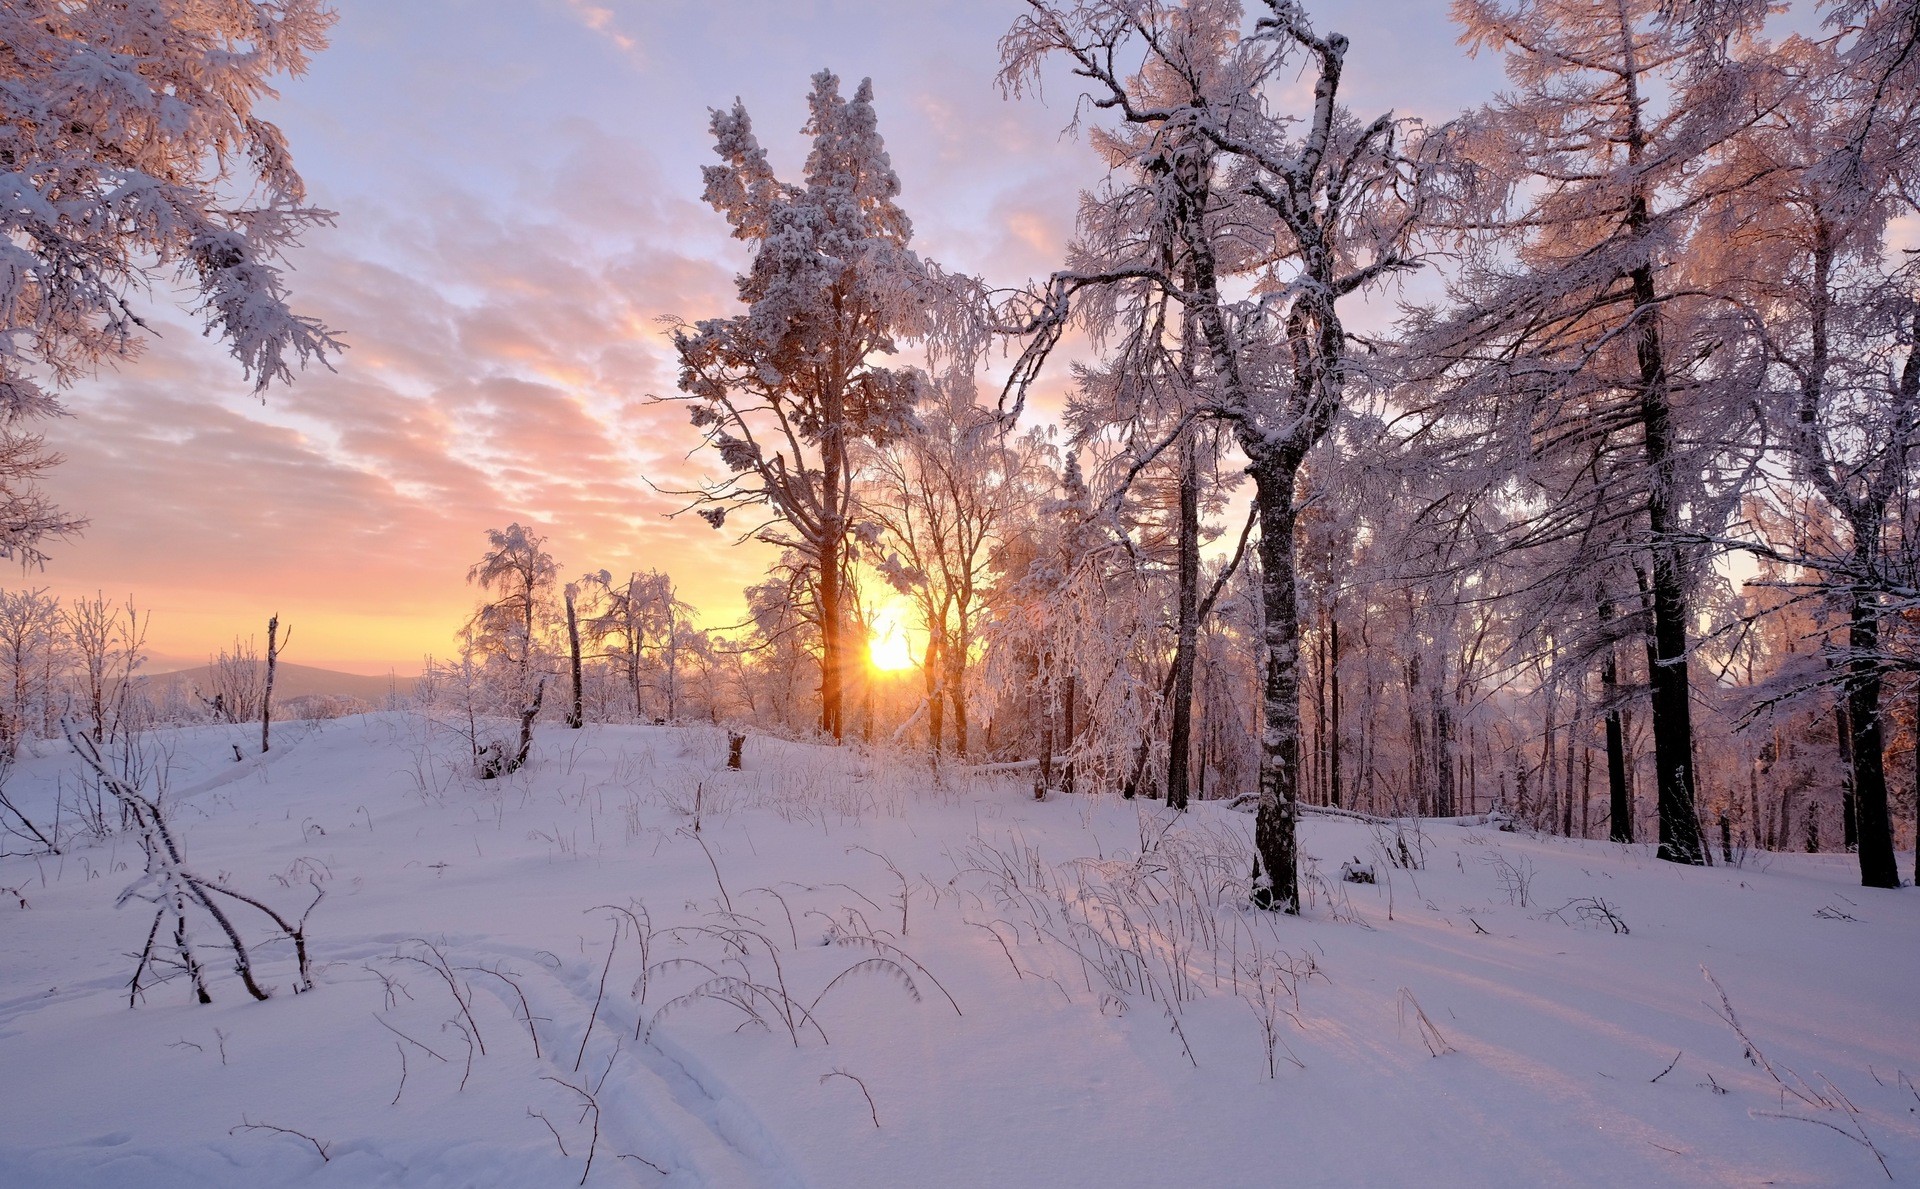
[{"xmin": 33, "ymin": 0, "xmax": 1500, "ymax": 674}]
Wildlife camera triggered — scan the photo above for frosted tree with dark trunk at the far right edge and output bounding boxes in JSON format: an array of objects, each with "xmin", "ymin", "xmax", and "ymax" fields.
[{"xmin": 1715, "ymin": 23, "xmax": 1920, "ymax": 887}]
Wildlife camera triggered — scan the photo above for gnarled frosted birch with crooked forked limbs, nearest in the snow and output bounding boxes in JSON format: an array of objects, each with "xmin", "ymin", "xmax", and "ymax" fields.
[{"xmin": 1002, "ymin": 0, "xmax": 1425, "ymax": 912}]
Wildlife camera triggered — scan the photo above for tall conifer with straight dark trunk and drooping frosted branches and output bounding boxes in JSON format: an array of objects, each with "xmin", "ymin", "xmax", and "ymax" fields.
[{"xmin": 1411, "ymin": 0, "xmax": 1778, "ymax": 862}]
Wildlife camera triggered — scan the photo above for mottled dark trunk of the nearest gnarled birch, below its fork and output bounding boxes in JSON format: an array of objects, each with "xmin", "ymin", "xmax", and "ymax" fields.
[{"xmin": 1250, "ymin": 457, "xmax": 1300, "ymax": 914}]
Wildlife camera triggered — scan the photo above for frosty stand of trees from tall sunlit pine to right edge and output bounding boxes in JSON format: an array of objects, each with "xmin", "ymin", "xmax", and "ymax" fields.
[{"xmin": 633, "ymin": 0, "xmax": 1920, "ymax": 909}]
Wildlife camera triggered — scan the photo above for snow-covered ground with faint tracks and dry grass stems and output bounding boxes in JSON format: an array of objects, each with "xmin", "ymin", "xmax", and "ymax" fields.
[{"xmin": 0, "ymin": 713, "xmax": 1920, "ymax": 1189}]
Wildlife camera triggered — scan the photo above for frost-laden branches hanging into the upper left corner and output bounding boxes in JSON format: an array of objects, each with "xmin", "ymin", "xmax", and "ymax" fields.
[{"xmin": 0, "ymin": 0, "xmax": 340, "ymax": 563}]
